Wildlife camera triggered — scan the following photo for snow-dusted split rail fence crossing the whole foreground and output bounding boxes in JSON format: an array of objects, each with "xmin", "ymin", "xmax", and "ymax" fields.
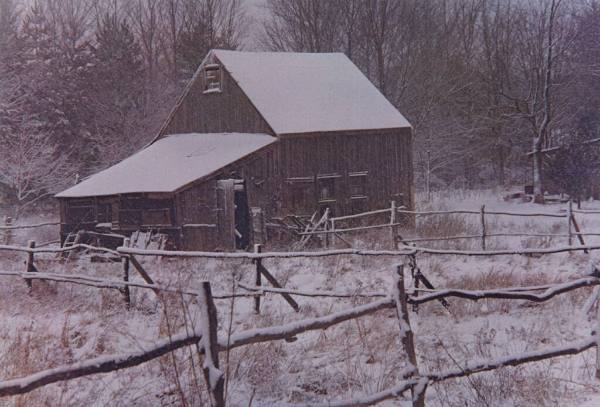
[{"xmin": 0, "ymin": 242, "xmax": 600, "ymax": 407}]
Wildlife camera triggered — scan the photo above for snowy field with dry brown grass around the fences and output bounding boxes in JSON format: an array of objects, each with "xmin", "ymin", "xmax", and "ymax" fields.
[{"xmin": 0, "ymin": 191, "xmax": 600, "ymax": 406}]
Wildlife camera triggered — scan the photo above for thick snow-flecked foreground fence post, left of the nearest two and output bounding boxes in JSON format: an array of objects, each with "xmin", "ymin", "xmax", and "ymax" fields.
[{"xmin": 200, "ymin": 281, "xmax": 225, "ymax": 407}]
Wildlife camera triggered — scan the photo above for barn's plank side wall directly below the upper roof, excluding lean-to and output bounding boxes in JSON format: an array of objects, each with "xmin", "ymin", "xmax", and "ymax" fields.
[{"xmin": 279, "ymin": 129, "xmax": 414, "ymax": 215}]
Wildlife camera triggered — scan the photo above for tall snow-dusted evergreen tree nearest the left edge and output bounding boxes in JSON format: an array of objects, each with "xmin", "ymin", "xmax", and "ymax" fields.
[{"xmin": 13, "ymin": 0, "xmax": 93, "ymax": 163}]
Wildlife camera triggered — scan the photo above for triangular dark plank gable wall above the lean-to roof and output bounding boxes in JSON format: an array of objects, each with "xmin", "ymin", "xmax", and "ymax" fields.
[{"xmin": 159, "ymin": 55, "xmax": 273, "ymax": 137}]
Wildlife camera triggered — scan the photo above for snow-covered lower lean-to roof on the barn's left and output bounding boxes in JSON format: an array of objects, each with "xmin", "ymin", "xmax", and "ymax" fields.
[{"xmin": 56, "ymin": 133, "xmax": 277, "ymax": 198}]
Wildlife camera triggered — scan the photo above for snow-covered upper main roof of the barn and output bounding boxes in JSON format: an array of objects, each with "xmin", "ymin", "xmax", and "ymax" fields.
[{"xmin": 212, "ymin": 50, "xmax": 410, "ymax": 134}]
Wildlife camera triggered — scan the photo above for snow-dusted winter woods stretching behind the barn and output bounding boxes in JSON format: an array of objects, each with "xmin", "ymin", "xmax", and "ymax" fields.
[{"xmin": 0, "ymin": 0, "xmax": 600, "ymax": 217}]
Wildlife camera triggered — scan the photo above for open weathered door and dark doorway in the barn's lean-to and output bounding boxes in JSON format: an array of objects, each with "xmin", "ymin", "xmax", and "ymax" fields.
[{"xmin": 217, "ymin": 179, "xmax": 250, "ymax": 250}]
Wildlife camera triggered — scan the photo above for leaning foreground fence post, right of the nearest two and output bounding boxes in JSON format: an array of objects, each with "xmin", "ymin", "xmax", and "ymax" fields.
[{"xmin": 394, "ymin": 264, "xmax": 427, "ymax": 407}]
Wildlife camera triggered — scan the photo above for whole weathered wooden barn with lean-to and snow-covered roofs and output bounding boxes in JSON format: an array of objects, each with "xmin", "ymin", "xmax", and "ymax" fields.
[{"xmin": 56, "ymin": 50, "xmax": 414, "ymax": 250}]
